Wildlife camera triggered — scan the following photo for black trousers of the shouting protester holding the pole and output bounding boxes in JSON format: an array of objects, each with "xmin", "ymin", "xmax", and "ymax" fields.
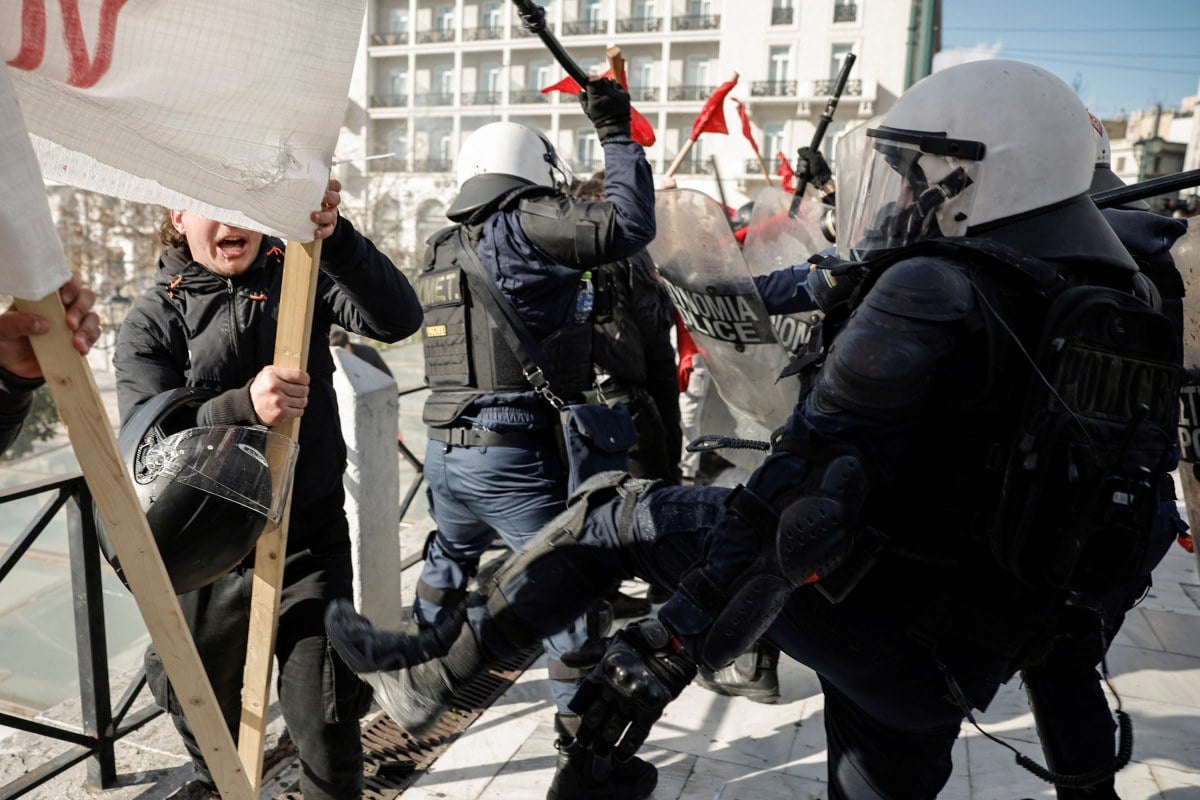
[{"xmin": 145, "ymin": 546, "xmax": 371, "ymax": 800}]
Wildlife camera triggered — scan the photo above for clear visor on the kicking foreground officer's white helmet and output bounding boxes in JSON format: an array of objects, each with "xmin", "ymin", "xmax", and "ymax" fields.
[{"xmin": 838, "ymin": 126, "xmax": 984, "ymax": 260}]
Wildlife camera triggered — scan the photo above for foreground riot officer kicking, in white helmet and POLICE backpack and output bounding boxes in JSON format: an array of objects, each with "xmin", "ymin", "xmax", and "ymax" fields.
[{"xmin": 328, "ymin": 60, "xmax": 1175, "ymax": 800}]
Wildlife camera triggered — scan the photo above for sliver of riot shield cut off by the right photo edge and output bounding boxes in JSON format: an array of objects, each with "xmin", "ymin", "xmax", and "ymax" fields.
[{"xmin": 1171, "ymin": 217, "xmax": 1200, "ymax": 569}]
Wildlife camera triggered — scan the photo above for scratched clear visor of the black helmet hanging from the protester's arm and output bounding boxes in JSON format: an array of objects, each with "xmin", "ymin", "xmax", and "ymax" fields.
[{"xmin": 142, "ymin": 426, "xmax": 300, "ymax": 522}]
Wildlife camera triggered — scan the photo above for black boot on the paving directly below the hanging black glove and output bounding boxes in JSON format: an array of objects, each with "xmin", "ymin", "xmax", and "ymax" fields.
[{"xmin": 546, "ymin": 714, "xmax": 659, "ymax": 800}]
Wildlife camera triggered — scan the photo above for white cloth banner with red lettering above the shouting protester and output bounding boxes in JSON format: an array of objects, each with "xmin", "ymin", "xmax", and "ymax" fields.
[{"xmin": 0, "ymin": 0, "xmax": 366, "ymax": 297}]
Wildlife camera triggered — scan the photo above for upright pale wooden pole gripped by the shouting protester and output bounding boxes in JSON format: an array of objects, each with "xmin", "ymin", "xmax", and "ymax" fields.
[{"xmin": 231, "ymin": 240, "xmax": 322, "ymax": 792}]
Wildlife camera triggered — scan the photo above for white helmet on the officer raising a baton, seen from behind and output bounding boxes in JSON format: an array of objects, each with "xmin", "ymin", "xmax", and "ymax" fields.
[{"xmin": 446, "ymin": 122, "xmax": 574, "ymax": 222}]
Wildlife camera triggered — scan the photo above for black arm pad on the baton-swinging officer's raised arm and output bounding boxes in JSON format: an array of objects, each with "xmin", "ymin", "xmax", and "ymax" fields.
[{"xmin": 518, "ymin": 194, "xmax": 617, "ymax": 267}]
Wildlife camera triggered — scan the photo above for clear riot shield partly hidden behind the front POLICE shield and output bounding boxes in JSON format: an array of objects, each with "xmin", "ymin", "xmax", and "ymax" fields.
[{"xmin": 742, "ymin": 186, "xmax": 833, "ymax": 357}]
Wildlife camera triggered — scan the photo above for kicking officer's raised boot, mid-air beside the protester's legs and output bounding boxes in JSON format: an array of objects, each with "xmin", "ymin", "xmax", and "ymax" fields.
[{"xmin": 325, "ymin": 600, "xmax": 490, "ymax": 736}]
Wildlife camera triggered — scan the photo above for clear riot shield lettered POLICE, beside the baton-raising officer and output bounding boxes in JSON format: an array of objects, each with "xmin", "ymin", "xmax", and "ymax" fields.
[{"xmin": 648, "ymin": 190, "xmax": 799, "ymax": 455}]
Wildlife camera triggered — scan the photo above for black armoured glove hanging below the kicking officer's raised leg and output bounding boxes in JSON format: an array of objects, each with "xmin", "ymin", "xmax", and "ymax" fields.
[{"xmin": 570, "ymin": 618, "xmax": 696, "ymax": 760}]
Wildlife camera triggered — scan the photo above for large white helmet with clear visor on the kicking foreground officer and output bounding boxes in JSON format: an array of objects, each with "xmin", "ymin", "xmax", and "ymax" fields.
[{"xmin": 846, "ymin": 60, "xmax": 1096, "ymax": 257}]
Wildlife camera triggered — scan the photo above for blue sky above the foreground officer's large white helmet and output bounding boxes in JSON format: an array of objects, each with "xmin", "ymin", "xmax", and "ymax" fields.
[{"xmin": 935, "ymin": 0, "xmax": 1200, "ymax": 119}]
